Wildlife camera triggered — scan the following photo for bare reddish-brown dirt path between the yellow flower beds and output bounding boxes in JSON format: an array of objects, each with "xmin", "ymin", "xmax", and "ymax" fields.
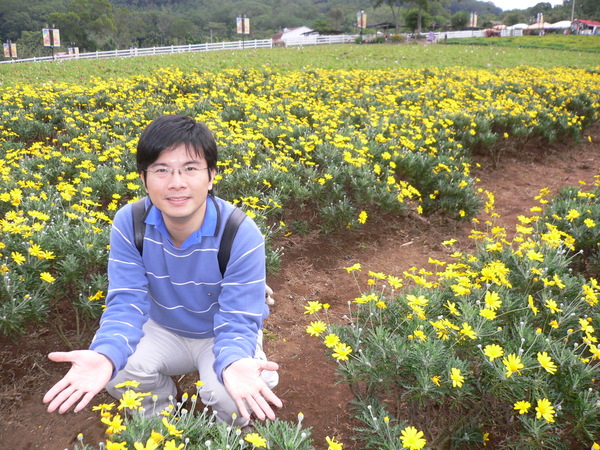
[{"xmin": 0, "ymin": 126, "xmax": 600, "ymax": 450}]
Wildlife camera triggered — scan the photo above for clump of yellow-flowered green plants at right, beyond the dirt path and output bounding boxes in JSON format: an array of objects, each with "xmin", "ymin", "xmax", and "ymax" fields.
[{"xmin": 313, "ymin": 188, "xmax": 600, "ymax": 449}]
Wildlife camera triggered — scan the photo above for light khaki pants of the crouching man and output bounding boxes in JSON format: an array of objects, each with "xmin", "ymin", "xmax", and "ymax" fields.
[{"xmin": 106, "ymin": 320, "xmax": 279, "ymax": 427}]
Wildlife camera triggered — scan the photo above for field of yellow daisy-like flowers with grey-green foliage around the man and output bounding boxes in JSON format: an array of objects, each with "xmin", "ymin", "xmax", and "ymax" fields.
[{"xmin": 0, "ymin": 41, "xmax": 600, "ymax": 449}]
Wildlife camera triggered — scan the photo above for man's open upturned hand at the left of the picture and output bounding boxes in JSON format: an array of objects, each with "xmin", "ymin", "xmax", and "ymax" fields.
[{"xmin": 43, "ymin": 350, "xmax": 113, "ymax": 414}]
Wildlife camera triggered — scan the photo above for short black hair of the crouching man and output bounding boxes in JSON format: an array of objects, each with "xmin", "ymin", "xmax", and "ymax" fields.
[{"xmin": 136, "ymin": 114, "xmax": 218, "ymax": 177}]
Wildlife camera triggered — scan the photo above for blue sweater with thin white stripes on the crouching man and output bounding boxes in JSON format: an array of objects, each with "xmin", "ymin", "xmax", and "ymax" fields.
[{"xmin": 90, "ymin": 196, "xmax": 269, "ymax": 381}]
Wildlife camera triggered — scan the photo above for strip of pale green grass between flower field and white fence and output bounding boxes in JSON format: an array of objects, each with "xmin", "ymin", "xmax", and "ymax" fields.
[{"xmin": 0, "ymin": 36, "xmax": 600, "ymax": 86}]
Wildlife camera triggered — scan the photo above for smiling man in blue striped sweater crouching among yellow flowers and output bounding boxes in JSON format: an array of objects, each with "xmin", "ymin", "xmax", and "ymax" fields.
[{"xmin": 43, "ymin": 115, "xmax": 282, "ymax": 426}]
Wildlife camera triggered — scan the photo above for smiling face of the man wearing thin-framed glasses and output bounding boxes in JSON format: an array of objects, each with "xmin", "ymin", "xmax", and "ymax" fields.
[{"xmin": 142, "ymin": 144, "xmax": 215, "ymax": 234}]
